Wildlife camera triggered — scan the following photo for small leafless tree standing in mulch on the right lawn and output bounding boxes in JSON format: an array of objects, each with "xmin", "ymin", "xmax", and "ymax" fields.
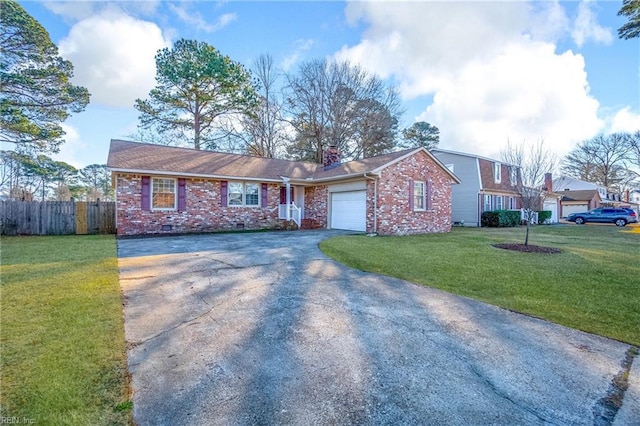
[{"xmin": 501, "ymin": 139, "xmax": 558, "ymax": 245}]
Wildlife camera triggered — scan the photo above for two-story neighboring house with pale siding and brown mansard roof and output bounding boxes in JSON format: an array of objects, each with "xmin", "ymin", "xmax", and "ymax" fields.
[{"xmin": 431, "ymin": 149, "xmax": 520, "ymax": 226}]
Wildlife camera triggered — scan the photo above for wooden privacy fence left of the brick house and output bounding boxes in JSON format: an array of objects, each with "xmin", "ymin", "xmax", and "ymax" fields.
[{"xmin": 0, "ymin": 201, "xmax": 116, "ymax": 235}]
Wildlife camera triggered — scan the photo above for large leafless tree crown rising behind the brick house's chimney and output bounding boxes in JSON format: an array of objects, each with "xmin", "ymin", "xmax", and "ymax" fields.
[{"xmin": 285, "ymin": 60, "xmax": 401, "ymax": 163}]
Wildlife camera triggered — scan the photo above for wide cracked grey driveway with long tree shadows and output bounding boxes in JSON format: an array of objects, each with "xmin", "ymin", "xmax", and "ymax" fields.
[{"xmin": 118, "ymin": 231, "xmax": 640, "ymax": 425}]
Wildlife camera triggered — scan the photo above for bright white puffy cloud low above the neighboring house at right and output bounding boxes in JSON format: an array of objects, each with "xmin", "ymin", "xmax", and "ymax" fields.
[{"xmin": 419, "ymin": 43, "xmax": 602, "ymax": 157}]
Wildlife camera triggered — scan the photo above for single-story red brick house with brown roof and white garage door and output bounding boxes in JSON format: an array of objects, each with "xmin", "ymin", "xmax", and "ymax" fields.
[{"xmin": 107, "ymin": 140, "xmax": 460, "ymax": 236}]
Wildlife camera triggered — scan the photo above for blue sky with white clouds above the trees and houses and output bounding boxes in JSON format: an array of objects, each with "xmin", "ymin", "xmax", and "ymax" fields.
[{"xmin": 13, "ymin": 1, "xmax": 640, "ymax": 167}]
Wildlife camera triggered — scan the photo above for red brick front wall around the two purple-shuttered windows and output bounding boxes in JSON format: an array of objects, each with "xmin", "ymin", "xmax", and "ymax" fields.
[{"xmin": 116, "ymin": 173, "xmax": 283, "ymax": 235}]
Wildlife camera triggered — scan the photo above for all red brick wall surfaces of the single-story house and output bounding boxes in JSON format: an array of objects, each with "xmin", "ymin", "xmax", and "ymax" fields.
[{"xmin": 115, "ymin": 152, "xmax": 451, "ymax": 236}]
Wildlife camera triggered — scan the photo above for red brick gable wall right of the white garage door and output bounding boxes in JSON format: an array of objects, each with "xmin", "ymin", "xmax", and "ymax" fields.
[{"xmin": 376, "ymin": 152, "xmax": 451, "ymax": 235}]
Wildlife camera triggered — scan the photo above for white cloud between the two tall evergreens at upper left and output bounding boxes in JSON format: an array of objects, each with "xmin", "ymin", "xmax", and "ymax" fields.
[{"xmin": 59, "ymin": 7, "xmax": 170, "ymax": 107}]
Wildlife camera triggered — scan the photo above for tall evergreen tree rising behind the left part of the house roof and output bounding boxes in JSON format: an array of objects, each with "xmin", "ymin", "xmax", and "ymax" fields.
[{"xmin": 135, "ymin": 39, "xmax": 257, "ymax": 149}]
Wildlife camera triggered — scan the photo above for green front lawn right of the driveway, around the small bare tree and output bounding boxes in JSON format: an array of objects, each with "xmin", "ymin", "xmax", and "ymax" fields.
[{"xmin": 320, "ymin": 225, "xmax": 640, "ymax": 345}]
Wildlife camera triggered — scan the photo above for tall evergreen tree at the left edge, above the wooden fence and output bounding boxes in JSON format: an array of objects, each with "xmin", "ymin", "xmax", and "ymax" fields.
[{"xmin": 0, "ymin": 0, "xmax": 89, "ymax": 152}]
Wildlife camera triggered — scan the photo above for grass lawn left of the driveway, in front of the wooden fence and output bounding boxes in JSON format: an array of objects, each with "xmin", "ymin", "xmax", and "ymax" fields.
[{"xmin": 0, "ymin": 236, "xmax": 132, "ymax": 425}]
